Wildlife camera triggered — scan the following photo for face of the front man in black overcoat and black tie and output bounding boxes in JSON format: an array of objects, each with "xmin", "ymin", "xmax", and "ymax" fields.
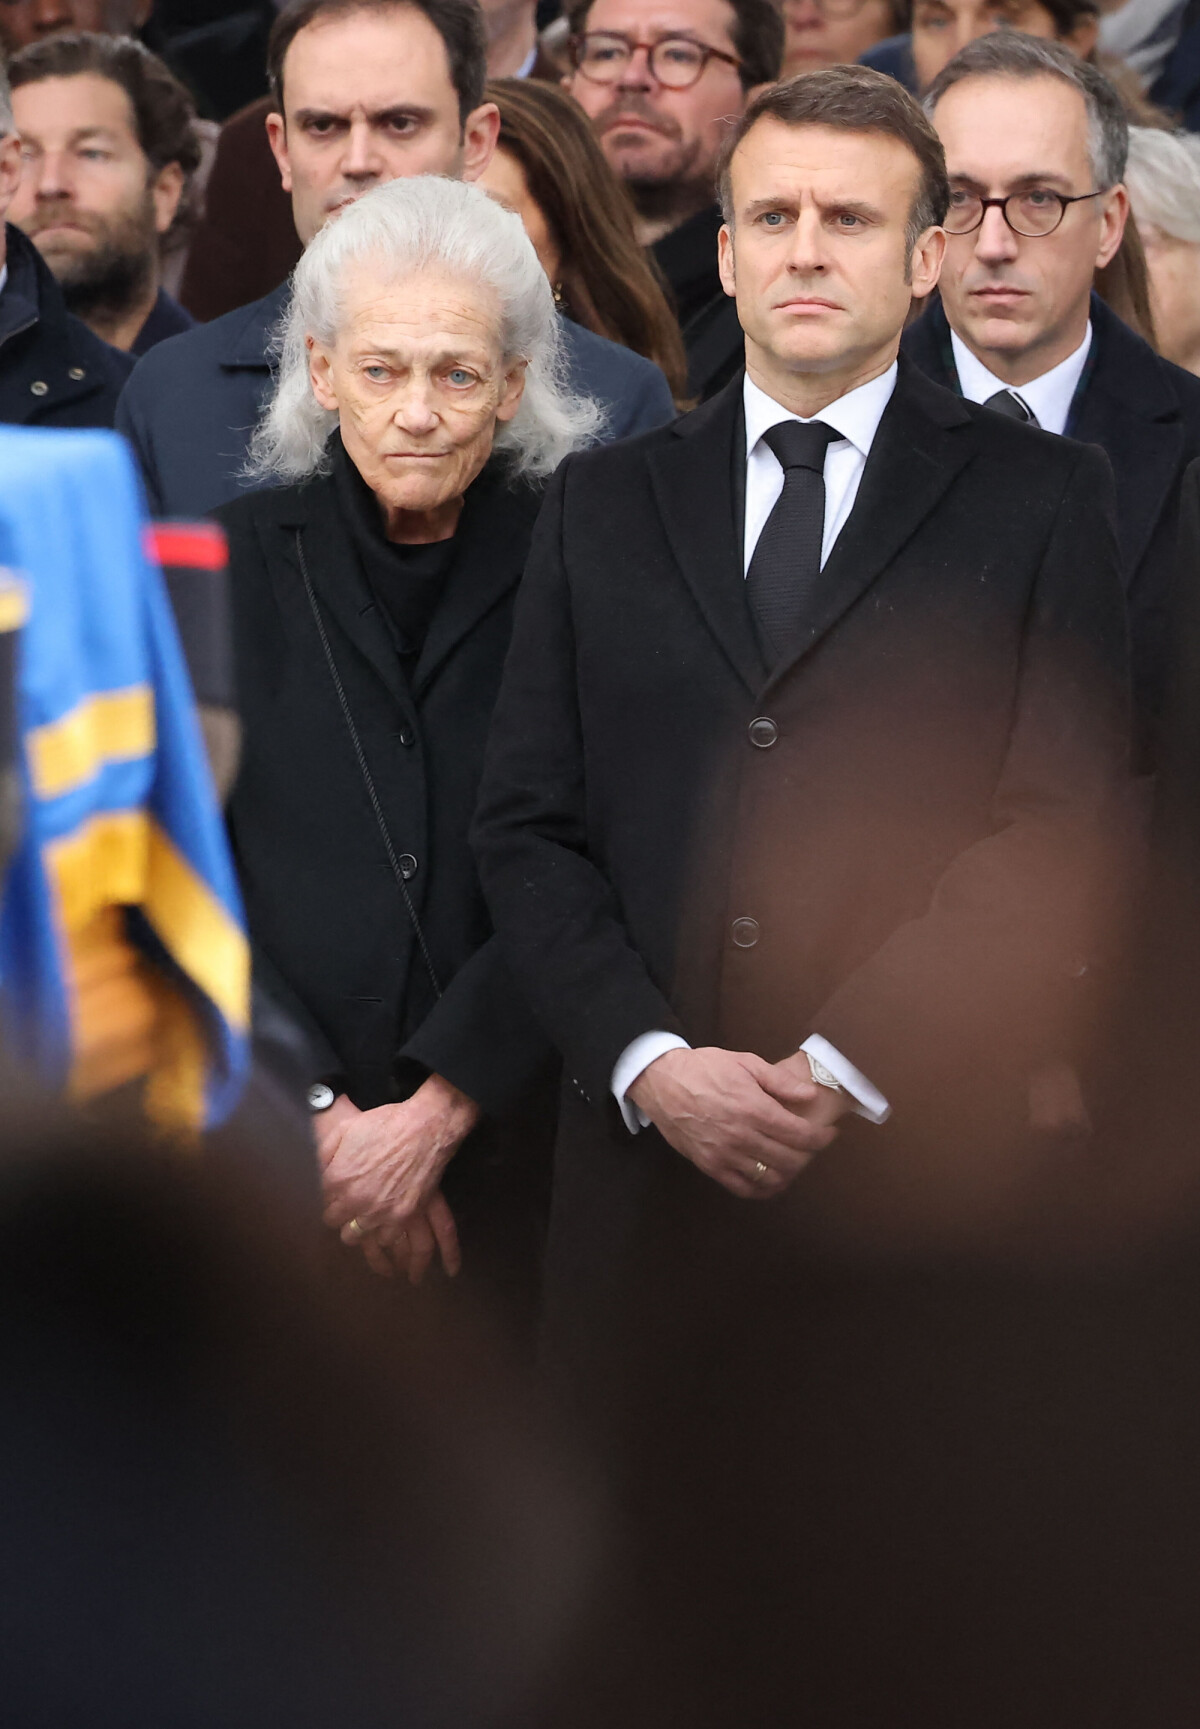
[{"xmin": 719, "ymin": 118, "xmax": 941, "ymax": 387}]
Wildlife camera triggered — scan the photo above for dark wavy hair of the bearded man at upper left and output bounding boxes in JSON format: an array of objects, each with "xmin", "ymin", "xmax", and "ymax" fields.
[{"xmin": 9, "ymin": 31, "xmax": 201, "ymax": 175}]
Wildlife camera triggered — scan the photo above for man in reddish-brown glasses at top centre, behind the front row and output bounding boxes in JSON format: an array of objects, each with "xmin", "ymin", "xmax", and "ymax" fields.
[{"xmin": 567, "ymin": 0, "xmax": 783, "ymax": 398}]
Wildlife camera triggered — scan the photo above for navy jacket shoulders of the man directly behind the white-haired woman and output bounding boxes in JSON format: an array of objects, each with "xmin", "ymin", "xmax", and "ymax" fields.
[{"xmin": 118, "ymin": 284, "xmax": 674, "ymax": 517}]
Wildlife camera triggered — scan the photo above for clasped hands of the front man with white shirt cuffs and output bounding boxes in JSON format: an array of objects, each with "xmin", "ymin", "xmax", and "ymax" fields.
[{"xmin": 629, "ymin": 1048, "xmax": 842, "ymax": 1200}]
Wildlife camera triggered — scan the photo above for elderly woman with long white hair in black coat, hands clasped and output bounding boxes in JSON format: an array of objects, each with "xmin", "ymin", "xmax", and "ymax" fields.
[{"xmin": 220, "ymin": 176, "xmax": 600, "ymax": 1281}]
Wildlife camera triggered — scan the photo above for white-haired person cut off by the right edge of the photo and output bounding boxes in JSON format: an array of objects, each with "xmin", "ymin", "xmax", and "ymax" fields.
[{"xmin": 1126, "ymin": 126, "xmax": 1200, "ymax": 373}]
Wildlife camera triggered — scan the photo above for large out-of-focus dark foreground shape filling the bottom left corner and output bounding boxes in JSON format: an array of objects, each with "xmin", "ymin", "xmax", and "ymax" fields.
[{"xmin": 0, "ymin": 1094, "xmax": 590, "ymax": 1729}]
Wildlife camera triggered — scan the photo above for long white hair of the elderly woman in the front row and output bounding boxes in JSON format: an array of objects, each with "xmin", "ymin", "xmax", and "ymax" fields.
[{"xmin": 246, "ymin": 175, "xmax": 603, "ymax": 481}]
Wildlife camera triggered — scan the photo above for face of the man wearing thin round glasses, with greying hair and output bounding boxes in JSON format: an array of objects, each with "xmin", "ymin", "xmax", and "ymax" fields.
[{"xmin": 934, "ymin": 76, "xmax": 1129, "ymax": 384}]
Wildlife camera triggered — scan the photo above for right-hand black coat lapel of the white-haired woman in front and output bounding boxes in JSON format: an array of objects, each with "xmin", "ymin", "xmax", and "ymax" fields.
[{"xmin": 413, "ymin": 463, "xmax": 541, "ymax": 695}]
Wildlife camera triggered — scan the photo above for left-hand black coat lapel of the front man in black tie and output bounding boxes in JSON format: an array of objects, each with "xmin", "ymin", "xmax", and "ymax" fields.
[{"xmin": 650, "ymin": 375, "xmax": 764, "ymax": 693}]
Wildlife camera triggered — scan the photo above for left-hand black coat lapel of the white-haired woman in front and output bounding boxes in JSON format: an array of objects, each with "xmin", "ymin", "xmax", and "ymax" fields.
[{"xmin": 269, "ymin": 475, "xmax": 406, "ymax": 702}]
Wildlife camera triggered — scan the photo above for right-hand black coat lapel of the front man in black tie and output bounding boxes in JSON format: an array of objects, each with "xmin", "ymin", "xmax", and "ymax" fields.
[{"xmin": 771, "ymin": 360, "xmax": 973, "ymax": 683}]
